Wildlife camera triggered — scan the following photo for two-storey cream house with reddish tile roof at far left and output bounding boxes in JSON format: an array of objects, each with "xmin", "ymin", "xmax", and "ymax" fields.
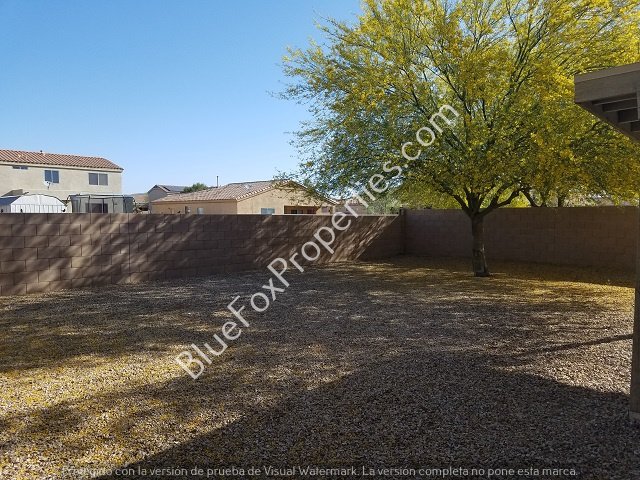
[{"xmin": 0, "ymin": 150, "xmax": 123, "ymax": 202}]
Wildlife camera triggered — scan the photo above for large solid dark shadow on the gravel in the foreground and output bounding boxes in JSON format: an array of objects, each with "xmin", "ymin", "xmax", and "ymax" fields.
[{"xmin": 101, "ymin": 350, "xmax": 640, "ymax": 480}]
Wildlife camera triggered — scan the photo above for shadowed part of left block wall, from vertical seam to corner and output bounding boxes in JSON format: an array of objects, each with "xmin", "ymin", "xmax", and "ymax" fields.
[{"xmin": 112, "ymin": 215, "xmax": 402, "ymax": 283}]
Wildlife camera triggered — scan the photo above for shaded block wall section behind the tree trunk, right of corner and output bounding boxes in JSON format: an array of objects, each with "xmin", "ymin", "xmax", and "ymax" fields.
[{"xmin": 405, "ymin": 207, "xmax": 638, "ymax": 271}]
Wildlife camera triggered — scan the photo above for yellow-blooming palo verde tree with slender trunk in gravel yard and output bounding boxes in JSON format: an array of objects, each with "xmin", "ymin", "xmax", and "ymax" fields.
[{"xmin": 284, "ymin": 0, "xmax": 640, "ymax": 276}]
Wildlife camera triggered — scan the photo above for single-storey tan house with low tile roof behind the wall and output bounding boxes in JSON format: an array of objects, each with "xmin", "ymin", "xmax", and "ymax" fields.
[{"xmin": 151, "ymin": 180, "xmax": 337, "ymax": 215}]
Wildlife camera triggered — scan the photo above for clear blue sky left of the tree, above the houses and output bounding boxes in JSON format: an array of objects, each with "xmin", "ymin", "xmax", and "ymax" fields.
[{"xmin": 0, "ymin": 0, "xmax": 360, "ymax": 193}]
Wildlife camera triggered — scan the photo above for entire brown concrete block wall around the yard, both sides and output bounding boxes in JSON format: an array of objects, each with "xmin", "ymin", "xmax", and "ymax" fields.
[{"xmin": 0, "ymin": 207, "xmax": 638, "ymax": 295}]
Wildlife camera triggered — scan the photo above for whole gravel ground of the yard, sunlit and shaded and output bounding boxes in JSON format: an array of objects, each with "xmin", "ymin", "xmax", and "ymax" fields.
[{"xmin": 0, "ymin": 257, "xmax": 640, "ymax": 480}]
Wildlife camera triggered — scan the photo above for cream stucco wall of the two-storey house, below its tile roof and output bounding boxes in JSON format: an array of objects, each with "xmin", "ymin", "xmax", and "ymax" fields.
[{"xmin": 0, "ymin": 162, "xmax": 122, "ymax": 201}]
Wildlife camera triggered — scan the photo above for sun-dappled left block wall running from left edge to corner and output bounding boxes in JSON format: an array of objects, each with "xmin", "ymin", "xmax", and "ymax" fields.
[{"xmin": 0, "ymin": 214, "xmax": 402, "ymax": 295}]
